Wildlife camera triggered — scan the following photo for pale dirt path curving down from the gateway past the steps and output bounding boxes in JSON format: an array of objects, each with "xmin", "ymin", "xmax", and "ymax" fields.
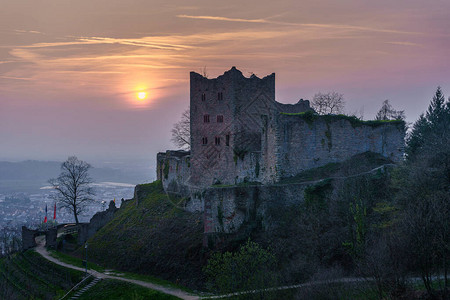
[{"xmin": 36, "ymin": 237, "xmax": 200, "ymax": 300}]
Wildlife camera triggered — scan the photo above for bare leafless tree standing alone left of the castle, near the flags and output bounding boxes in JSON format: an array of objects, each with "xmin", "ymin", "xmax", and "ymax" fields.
[{"xmin": 48, "ymin": 156, "xmax": 94, "ymax": 225}]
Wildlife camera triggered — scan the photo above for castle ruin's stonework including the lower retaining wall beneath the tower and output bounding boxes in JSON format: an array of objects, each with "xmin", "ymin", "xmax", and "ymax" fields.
[{"xmin": 157, "ymin": 67, "xmax": 405, "ymax": 246}]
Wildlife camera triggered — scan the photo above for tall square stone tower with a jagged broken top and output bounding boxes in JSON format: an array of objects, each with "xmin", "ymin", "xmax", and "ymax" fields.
[{"xmin": 189, "ymin": 67, "xmax": 276, "ymax": 187}]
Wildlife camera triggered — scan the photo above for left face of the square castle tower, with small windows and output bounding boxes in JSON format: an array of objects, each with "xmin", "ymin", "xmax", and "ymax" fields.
[{"xmin": 190, "ymin": 72, "xmax": 235, "ymax": 186}]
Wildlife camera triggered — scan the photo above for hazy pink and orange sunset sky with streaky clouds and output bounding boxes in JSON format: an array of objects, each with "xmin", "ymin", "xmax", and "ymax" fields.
[{"xmin": 0, "ymin": 0, "xmax": 450, "ymax": 166}]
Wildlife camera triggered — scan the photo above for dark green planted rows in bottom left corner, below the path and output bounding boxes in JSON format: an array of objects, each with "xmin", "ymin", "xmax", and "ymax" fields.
[{"xmin": 0, "ymin": 250, "xmax": 84, "ymax": 299}]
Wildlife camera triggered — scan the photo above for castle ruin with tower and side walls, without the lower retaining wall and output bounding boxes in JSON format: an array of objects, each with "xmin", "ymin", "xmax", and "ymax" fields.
[{"xmin": 157, "ymin": 67, "xmax": 405, "ymax": 194}]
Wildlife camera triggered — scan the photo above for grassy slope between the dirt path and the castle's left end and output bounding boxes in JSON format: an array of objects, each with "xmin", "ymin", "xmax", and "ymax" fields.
[{"xmin": 88, "ymin": 181, "xmax": 203, "ymax": 288}]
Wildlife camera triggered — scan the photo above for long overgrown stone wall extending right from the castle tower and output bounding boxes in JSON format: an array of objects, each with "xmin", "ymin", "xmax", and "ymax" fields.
[{"xmin": 275, "ymin": 114, "xmax": 405, "ymax": 177}]
